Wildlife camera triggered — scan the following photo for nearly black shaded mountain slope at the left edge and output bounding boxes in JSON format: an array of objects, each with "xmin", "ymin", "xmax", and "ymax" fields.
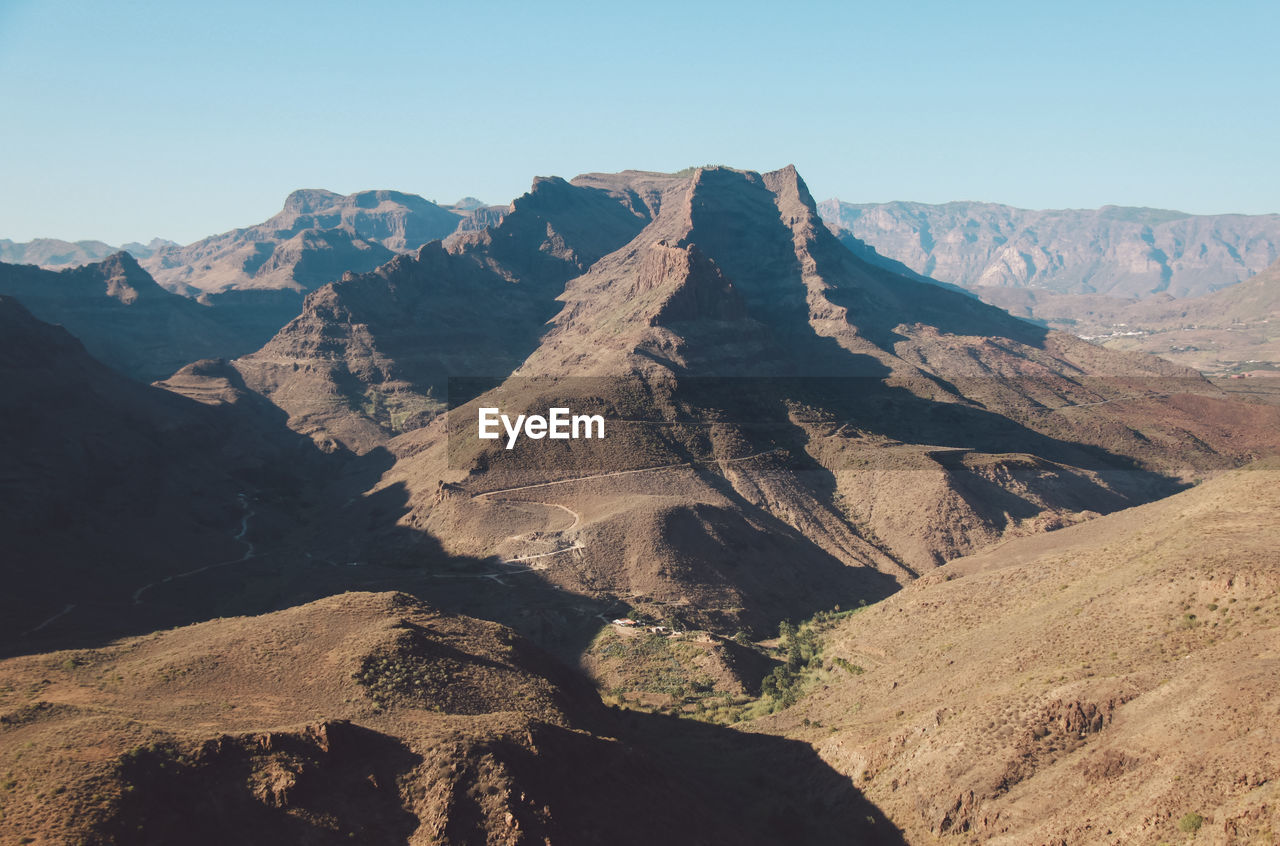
[{"xmin": 0, "ymin": 294, "xmax": 335, "ymax": 642}]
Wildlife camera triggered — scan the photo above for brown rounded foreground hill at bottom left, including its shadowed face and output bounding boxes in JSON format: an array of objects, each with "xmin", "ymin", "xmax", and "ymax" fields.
[{"xmin": 0, "ymin": 593, "xmax": 901, "ymax": 846}]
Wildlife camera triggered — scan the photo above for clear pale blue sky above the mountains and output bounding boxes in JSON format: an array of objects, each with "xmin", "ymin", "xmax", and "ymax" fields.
[{"xmin": 0, "ymin": 0, "xmax": 1280, "ymax": 243}]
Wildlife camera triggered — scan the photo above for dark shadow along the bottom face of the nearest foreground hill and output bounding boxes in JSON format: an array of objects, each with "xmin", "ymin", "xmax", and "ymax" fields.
[{"xmin": 72, "ymin": 670, "xmax": 905, "ymax": 846}]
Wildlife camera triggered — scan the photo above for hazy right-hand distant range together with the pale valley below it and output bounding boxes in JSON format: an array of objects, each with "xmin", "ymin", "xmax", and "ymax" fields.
[{"xmin": 819, "ymin": 200, "xmax": 1280, "ymax": 374}]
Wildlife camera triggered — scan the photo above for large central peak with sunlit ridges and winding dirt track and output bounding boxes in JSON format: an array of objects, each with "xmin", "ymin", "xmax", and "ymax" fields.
[{"xmin": 373, "ymin": 169, "xmax": 1280, "ymax": 631}]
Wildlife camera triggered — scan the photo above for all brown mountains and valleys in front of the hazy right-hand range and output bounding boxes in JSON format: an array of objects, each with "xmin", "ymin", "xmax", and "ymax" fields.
[{"xmin": 0, "ymin": 166, "xmax": 1280, "ymax": 843}]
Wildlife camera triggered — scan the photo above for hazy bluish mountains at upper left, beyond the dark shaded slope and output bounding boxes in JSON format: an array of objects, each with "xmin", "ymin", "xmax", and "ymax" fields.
[{"xmin": 0, "ymin": 191, "xmax": 504, "ymax": 381}]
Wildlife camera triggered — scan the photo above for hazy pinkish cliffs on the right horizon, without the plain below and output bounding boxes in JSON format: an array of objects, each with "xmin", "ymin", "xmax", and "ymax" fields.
[{"xmin": 822, "ymin": 200, "xmax": 1280, "ymax": 297}]
